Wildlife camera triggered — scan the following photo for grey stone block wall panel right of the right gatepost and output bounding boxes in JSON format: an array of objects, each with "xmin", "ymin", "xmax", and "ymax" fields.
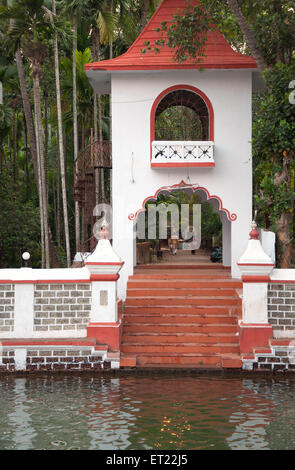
[{"xmin": 268, "ymin": 283, "xmax": 295, "ymax": 338}]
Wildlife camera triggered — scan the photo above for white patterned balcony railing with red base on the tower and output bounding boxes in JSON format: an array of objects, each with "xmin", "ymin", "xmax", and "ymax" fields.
[{"xmin": 151, "ymin": 140, "xmax": 215, "ymax": 167}]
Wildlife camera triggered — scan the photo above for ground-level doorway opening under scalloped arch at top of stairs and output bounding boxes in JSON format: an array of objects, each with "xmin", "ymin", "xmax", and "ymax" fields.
[{"xmin": 134, "ymin": 184, "xmax": 236, "ymax": 267}]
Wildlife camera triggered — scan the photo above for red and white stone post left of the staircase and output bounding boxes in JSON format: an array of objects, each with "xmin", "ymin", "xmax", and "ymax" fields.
[{"xmin": 85, "ymin": 239, "xmax": 124, "ymax": 350}]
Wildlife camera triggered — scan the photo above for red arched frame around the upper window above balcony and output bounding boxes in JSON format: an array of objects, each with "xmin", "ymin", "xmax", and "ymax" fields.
[{"xmin": 150, "ymin": 85, "xmax": 214, "ymax": 155}]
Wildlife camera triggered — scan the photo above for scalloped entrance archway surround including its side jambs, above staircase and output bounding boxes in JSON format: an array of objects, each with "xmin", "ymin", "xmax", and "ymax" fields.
[{"xmin": 128, "ymin": 181, "xmax": 237, "ymax": 267}]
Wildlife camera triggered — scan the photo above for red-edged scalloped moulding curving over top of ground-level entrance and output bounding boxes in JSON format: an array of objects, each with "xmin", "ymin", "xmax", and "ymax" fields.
[{"xmin": 128, "ymin": 181, "xmax": 238, "ymax": 222}]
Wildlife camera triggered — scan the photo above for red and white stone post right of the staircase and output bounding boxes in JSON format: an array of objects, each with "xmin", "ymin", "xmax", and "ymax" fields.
[{"xmin": 238, "ymin": 222, "xmax": 274, "ymax": 353}]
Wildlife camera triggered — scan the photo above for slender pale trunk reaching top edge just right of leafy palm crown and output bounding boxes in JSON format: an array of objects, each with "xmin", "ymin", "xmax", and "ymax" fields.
[{"xmin": 52, "ymin": 0, "xmax": 71, "ymax": 268}]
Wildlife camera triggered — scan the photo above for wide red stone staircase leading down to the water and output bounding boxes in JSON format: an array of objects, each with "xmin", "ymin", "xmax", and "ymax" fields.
[{"xmin": 120, "ymin": 265, "xmax": 242, "ymax": 369}]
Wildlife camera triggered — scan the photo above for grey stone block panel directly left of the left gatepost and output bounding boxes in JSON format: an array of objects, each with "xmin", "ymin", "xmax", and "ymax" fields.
[{"xmin": 34, "ymin": 283, "xmax": 91, "ymax": 334}]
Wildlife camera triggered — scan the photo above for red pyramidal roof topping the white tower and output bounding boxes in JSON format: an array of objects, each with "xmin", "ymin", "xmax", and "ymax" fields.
[{"xmin": 85, "ymin": 0, "xmax": 257, "ymax": 71}]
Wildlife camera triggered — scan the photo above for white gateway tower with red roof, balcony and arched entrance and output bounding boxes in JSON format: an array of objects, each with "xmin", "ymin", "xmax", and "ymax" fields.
[{"xmin": 86, "ymin": 0, "xmax": 257, "ymax": 297}]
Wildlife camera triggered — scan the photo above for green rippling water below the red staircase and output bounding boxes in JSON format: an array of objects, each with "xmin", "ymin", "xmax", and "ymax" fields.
[{"xmin": 0, "ymin": 375, "xmax": 295, "ymax": 450}]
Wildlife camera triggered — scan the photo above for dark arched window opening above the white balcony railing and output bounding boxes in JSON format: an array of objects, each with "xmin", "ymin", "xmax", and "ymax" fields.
[{"xmin": 155, "ymin": 89, "xmax": 209, "ymax": 141}]
